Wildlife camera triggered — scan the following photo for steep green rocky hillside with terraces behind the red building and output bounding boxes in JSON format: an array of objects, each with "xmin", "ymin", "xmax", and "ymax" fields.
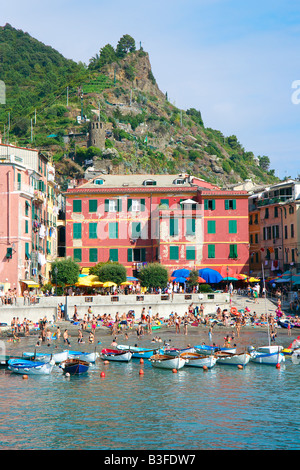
[{"xmin": 0, "ymin": 24, "xmax": 276, "ymax": 186}]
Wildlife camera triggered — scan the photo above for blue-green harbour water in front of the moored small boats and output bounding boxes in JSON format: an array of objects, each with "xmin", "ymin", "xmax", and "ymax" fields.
[{"xmin": 0, "ymin": 329, "xmax": 300, "ymax": 455}]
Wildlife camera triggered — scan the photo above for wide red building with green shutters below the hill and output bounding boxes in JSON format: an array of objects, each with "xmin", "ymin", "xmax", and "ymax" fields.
[{"xmin": 65, "ymin": 175, "xmax": 249, "ymax": 275}]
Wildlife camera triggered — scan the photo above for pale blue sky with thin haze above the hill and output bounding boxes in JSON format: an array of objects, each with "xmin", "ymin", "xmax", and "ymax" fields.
[{"xmin": 0, "ymin": 0, "xmax": 300, "ymax": 178}]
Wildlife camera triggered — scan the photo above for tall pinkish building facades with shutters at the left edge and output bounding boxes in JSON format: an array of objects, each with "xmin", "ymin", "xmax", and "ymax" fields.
[{"xmin": 0, "ymin": 144, "xmax": 62, "ymax": 294}]
